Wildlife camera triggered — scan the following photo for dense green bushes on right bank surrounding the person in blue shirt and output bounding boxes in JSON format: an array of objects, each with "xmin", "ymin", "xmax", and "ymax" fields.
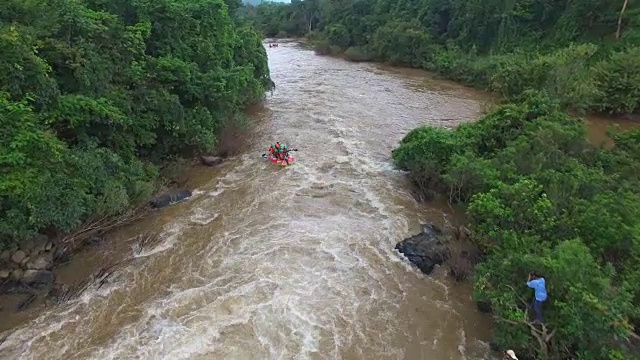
[{"xmin": 393, "ymin": 93, "xmax": 640, "ymax": 359}]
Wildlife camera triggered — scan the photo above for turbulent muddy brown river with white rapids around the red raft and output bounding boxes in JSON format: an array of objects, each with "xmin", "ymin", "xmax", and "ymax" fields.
[{"xmin": 0, "ymin": 43, "xmax": 636, "ymax": 359}]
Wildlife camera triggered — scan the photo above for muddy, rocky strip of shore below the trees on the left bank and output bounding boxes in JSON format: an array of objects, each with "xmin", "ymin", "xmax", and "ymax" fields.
[{"xmin": 0, "ymin": 103, "xmax": 264, "ymax": 333}]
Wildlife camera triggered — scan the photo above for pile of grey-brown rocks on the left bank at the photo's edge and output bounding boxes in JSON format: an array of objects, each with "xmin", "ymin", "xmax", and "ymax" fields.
[{"xmin": 0, "ymin": 236, "xmax": 56, "ymax": 285}]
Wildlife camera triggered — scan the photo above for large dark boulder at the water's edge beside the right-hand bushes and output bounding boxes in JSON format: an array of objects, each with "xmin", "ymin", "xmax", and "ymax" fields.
[{"xmin": 396, "ymin": 224, "xmax": 447, "ymax": 275}]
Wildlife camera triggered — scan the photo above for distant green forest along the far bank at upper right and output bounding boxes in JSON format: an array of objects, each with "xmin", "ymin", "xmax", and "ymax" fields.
[{"xmin": 243, "ymin": 0, "xmax": 640, "ymax": 113}]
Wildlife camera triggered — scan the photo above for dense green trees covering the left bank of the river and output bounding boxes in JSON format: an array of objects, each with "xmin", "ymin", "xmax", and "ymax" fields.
[{"xmin": 0, "ymin": 0, "xmax": 271, "ymax": 248}]
